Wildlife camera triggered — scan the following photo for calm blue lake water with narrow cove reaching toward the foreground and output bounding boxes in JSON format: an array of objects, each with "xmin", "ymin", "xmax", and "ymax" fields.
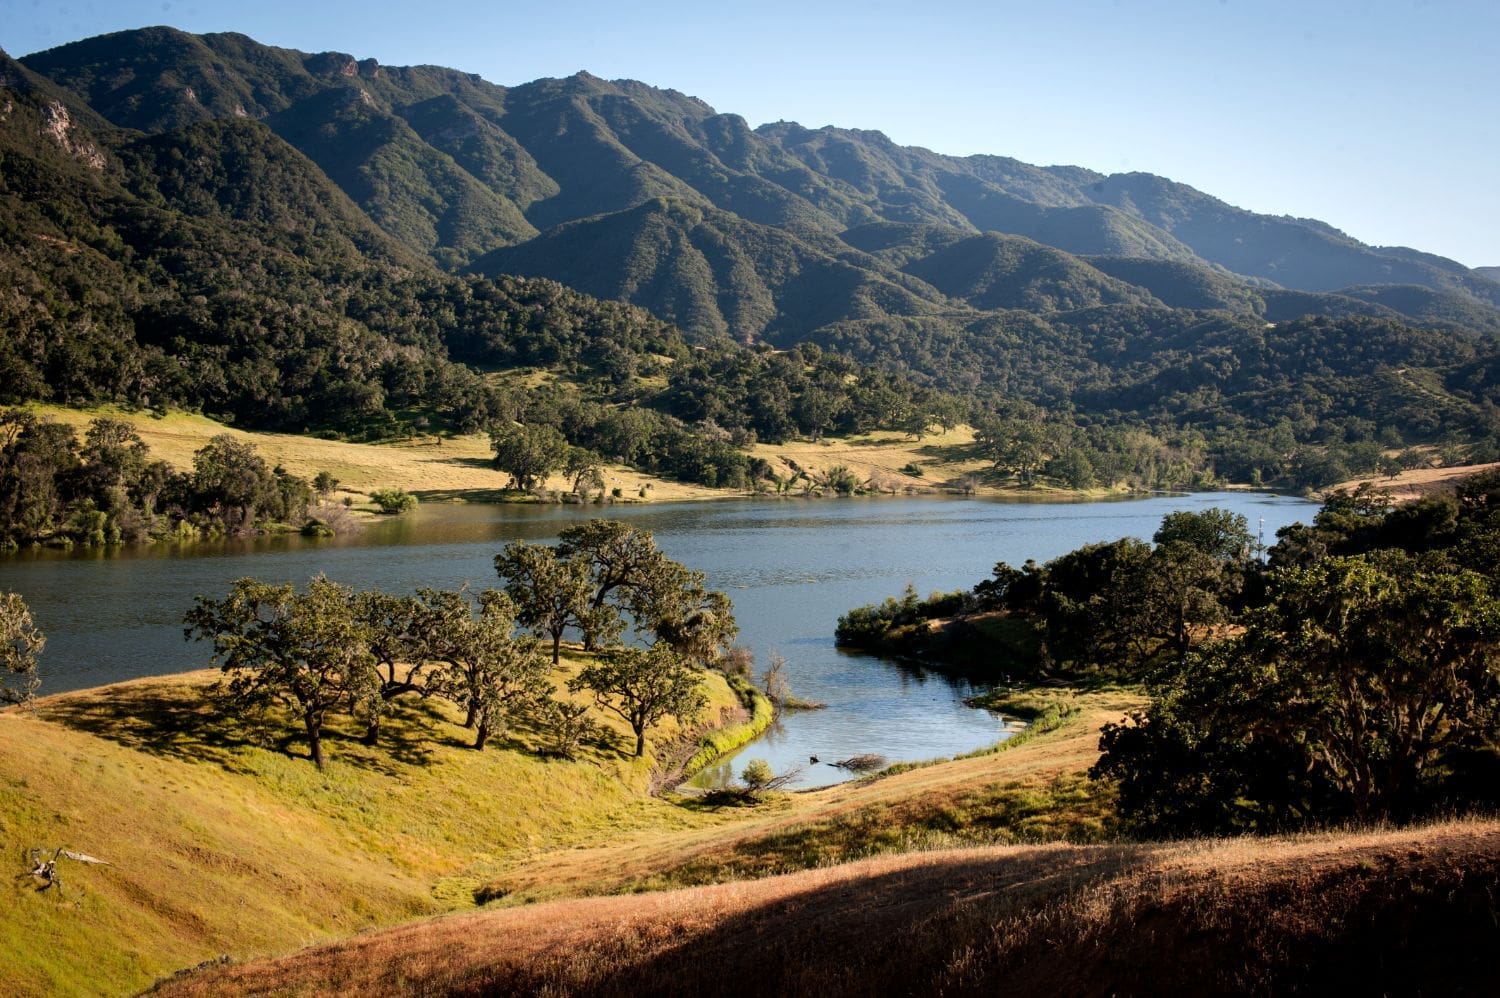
[{"xmin": 0, "ymin": 492, "xmax": 1317, "ymax": 786}]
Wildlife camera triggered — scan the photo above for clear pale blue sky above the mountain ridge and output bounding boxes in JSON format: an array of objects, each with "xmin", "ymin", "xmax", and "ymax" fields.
[{"xmin": 0, "ymin": 0, "xmax": 1500, "ymax": 266}]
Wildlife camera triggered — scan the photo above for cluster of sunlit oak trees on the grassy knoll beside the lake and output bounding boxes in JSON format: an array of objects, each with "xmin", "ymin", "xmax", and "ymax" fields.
[{"xmin": 185, "ymin": 519, "xmax": 738, "ymax": 768}]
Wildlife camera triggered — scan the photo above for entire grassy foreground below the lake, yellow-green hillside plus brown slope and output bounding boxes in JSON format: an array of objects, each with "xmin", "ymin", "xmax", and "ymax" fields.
[{"xmin": 11, "ymin": 642, "xmax": 1500, "ymax": 995}]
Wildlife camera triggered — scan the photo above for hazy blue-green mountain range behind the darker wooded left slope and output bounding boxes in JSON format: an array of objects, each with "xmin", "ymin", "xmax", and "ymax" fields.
[{"xmin": 23, "ymin": 29, "xmax": 1500, "ymax": 339}]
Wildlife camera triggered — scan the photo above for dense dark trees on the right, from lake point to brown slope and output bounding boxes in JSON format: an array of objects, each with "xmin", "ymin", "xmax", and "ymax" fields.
[{"xmin": 839, "ymin": 473, "xmax": 1500, "ymax": 836}]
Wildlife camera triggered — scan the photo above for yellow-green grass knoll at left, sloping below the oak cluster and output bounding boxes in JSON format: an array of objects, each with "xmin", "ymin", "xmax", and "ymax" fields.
[{"xmin": 0, "ymin": 657, "xmax": 737, "ymax": 995}]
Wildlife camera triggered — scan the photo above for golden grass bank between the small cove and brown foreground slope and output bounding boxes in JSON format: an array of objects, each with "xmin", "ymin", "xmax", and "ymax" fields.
[{"xmin": 468, "ymin": 690, "xmax": 1142, "ymax": 903}]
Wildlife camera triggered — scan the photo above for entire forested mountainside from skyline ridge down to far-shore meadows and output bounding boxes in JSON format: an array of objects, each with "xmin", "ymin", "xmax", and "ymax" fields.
[{"xmin": 0, "ymin": 29, "xmax": 1500, "ymax": 498}]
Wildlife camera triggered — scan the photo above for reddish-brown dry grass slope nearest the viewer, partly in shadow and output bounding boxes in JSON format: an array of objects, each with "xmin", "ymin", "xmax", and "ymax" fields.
[{"xmin": 161, "ymin": 821, "xmax": 1500, "ymax": 996}]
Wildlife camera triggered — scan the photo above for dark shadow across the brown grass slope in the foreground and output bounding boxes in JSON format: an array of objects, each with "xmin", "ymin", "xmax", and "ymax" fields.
[{"xmin": 585, "ymin": 843, "xmax": 1500, "ymax": 996}]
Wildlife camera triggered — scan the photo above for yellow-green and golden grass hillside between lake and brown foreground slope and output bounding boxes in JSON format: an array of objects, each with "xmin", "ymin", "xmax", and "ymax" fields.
[{"xmin": 0, "ymin": 672, "xmax": 1134, "ymax": 993}]
